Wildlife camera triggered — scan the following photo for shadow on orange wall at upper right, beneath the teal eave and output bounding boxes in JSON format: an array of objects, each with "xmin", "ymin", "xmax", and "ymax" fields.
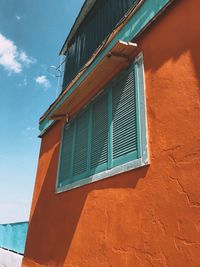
[{"xmin": 139, "ymin": 0, "xmax": 200, "ymax": 91}]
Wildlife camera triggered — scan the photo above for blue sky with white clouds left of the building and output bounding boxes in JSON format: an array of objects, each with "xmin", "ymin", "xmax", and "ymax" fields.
[{"xmin": 0, "ymin": 0, "xmax": 84, "ymax": 223}]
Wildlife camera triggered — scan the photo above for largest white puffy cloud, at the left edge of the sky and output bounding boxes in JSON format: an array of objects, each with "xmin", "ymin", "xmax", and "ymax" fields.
[{"xmin": 0, "ymin": 33, "xmax": 35, "ymax": 73}]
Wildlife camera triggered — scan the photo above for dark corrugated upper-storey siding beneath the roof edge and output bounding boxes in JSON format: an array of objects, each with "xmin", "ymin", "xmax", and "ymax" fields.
[{"xmin": 63, "ymin": 0, "xmax": 138, "ymax": 89}]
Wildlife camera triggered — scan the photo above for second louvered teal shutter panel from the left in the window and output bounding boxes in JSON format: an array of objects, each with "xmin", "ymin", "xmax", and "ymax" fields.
[{"xmin": 73, "ymin": 109, "xmax": 89, "ymax": 180}]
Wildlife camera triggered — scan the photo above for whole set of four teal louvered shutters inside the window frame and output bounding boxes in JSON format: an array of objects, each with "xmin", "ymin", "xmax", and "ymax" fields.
[{"xmin": 58, "ymin": 65, "xmax": 140, "ymax": 189}]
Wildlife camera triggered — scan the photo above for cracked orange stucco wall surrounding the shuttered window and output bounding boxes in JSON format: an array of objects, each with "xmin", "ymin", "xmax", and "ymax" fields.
[{"xmin": 23, "ymin": 0, "xmax": 200, "ymax": 267}]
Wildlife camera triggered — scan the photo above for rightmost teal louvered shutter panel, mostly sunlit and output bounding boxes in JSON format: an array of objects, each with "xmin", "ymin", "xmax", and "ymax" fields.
[{"xmin": 112, "ymin": 66, "xmax": 137, "ymax": 166}]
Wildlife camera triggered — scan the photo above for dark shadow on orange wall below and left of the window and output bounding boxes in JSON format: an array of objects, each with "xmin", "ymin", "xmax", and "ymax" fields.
[{"xmin": 24, "ymin": 129, "xmax": 148, "ymax": 266}]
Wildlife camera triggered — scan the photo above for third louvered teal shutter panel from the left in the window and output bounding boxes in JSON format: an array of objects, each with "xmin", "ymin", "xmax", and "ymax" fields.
[{"xmin": 91, "ymin": 93, "xmax": 108, "ymax": 174}]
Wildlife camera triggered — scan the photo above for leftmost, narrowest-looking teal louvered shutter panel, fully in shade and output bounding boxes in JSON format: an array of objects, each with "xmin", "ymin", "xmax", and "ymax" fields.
[{"xmin": 59, "ymin": 123, "xmax": 74, "ymax": 184}]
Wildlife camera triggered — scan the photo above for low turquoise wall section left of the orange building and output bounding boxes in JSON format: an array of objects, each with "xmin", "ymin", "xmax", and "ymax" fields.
[{"xmin": 0, "ymin": 222, "xmax": 28, "ymax": 254}]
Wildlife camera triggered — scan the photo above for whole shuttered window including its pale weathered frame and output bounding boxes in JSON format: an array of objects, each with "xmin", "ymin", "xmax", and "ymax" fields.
[{"xmin": 57, "ymin": 55, "xmax": 148, "ymax": 192}]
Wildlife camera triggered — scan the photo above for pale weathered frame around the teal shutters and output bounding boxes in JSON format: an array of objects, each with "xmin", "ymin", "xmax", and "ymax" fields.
[{"xmin": 56, "ymin": 53, "xmax": 149, "ymax": 193}]
